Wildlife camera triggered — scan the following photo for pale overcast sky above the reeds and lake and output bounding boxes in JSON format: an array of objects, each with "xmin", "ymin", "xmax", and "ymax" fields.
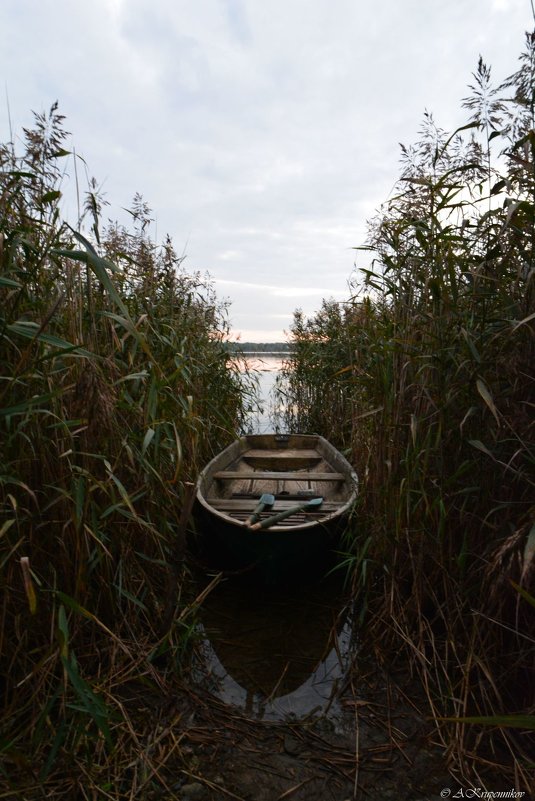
[{"xmin": 0, "ymin": 0, "xmax": 534, "ymax": 342}]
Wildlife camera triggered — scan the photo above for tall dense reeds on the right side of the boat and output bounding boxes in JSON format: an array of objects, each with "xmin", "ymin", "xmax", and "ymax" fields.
[{"xmin": 280, "ymin": 35, "xmax": 535, "ymax": 789}]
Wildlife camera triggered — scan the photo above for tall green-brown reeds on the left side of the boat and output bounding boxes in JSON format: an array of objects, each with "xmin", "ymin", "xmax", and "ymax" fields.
[{"xmin": 0, "ymin": 105, "xmax": 255, "ymax": 798}]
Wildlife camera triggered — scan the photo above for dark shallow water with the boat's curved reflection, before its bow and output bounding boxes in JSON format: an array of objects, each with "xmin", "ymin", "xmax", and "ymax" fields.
[{"xmin": 193, "ymin": 580, "xmax": 351, "ymax": 720}]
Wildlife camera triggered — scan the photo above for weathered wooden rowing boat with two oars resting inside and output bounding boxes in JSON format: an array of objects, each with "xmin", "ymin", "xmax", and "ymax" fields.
[{"xmin": 196, "ymin": 434, "xmax": 357, "ymax": 583}]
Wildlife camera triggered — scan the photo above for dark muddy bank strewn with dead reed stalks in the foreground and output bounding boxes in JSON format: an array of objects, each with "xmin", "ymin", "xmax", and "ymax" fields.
[{"xmin": 163, "ymin": 661, "xmax": 455, "ymax": 801}]
